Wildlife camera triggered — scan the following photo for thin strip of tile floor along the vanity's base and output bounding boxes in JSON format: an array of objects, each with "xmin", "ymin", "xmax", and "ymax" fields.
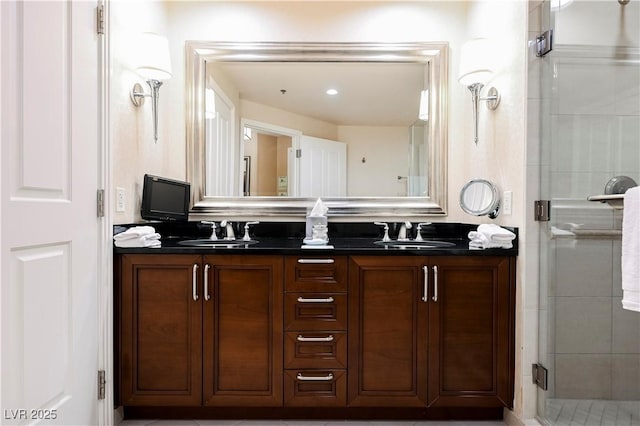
[{"xmin": 120, "ymin": 420, "xmax": 506, "ymax": 426}]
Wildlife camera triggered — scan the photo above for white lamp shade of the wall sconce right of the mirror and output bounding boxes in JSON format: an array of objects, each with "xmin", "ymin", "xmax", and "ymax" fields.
[{"xmin": 458, "ymin": 38, "xmax": 493, "ymax": 87}]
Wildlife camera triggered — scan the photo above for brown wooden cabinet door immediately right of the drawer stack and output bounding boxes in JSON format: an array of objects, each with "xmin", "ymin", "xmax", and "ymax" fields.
[{"xmin": 348, "ymin": 256, "xmax": 427, "ymax": 407}]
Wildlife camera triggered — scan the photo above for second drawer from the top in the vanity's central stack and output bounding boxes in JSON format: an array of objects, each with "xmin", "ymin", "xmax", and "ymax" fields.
[{"xmin": 284, "ymin": 293, "xmax": 347, "ymax": 331}]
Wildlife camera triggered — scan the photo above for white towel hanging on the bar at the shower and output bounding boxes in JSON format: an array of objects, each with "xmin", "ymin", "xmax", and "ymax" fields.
[{"xmin": 621, "ymin": 186, "xmax": 640, "ymax": 312}]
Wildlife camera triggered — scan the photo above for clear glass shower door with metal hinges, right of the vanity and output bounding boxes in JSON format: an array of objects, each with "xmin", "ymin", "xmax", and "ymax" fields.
[{"xmin": 538, "ymin": 1, "xmax": 640, "ymax": 425}]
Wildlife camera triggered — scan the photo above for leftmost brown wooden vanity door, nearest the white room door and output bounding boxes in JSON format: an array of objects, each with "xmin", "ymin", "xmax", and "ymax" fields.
[{"xmin": 120, "ymin": 254, "xmax": 202, "ymax": 406}]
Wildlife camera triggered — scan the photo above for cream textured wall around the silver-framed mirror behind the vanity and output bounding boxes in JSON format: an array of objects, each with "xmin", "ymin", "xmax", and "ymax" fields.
[{"xmin": 110, "ymin": 0, "xmax": 537, "ymax": 417}]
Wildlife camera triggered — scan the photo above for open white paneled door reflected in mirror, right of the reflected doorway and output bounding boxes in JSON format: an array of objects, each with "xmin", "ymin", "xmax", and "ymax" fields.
[{"xmin": 299, "ymin": 135, "xmax": 347, "ymax": 198}]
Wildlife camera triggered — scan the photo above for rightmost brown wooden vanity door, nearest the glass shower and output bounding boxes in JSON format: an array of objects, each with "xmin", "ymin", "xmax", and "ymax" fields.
[{"xmin": 429, "ymin": 256, "xmax": 515, "ymax": 407}]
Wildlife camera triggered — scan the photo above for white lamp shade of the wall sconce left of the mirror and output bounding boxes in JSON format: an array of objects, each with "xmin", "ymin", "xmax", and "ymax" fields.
[{"xmin": 136, "ymin": 33, "xmax": 172, "ymax": 80}]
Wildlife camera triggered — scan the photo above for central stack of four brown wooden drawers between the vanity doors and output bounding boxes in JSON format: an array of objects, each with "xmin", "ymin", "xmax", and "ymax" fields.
[{"xmin": 284, "ymin": 255, "xmax": 348, "ymax": 407}]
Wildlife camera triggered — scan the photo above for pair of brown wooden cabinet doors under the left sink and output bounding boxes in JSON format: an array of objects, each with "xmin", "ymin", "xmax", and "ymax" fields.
[{"xmin": 120, "ymin": 254, "xmax": 283, "ymax": 406}]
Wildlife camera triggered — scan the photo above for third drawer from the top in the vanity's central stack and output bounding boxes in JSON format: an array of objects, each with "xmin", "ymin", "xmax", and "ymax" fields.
[{"xmin": 284, "ymin": 331, "xmax": 347, "ymax": 368}]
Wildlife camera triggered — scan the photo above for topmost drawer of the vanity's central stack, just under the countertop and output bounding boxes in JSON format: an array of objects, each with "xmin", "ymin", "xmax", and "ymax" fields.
[{"xmin": 285, "ymin": 256, "xmax": 348, "ymax": 292}]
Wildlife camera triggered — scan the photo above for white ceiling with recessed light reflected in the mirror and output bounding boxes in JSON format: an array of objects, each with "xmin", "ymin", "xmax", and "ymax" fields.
[{"xmin": 207, "ymin": 62, "xmax": 426, "ymax": 126}]
